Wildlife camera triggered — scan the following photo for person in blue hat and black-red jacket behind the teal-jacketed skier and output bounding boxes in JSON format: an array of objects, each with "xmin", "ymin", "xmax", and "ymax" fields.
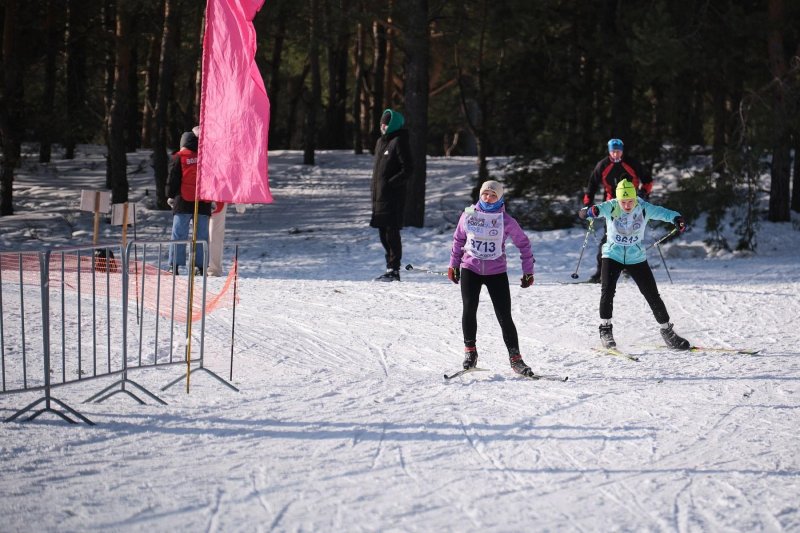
[{"xmin": 583, "ymin": 139, "xmax": 653, "ymax": 283}]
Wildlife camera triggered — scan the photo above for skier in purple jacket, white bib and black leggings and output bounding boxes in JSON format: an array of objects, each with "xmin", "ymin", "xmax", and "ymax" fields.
[{"xmin": 447, "ymin": 181, "xmax": 534, "ymax": 376}]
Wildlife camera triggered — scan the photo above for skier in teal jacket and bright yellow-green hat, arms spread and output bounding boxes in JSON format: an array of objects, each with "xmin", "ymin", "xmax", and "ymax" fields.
[{"xmin": 578, "ymin": 179, "xmax": 690, "ymax": 350}]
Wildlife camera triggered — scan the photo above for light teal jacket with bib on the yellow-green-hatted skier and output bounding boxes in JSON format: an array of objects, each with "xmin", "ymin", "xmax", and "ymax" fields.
[{"xmin": 596, "ymin": 198, "xmax": 680, "ymax": 265}]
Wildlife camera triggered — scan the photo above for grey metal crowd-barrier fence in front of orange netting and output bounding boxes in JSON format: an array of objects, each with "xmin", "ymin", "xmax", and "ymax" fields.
[{"xmin": 0, "ymin": 241, "xmax": 238, "ymax": 424}]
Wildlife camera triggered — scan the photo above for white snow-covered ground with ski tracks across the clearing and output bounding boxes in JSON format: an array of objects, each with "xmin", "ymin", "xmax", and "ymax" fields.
[{"xmin": 0, "ymin": 147, "xmax": 800, "ymax": 532}]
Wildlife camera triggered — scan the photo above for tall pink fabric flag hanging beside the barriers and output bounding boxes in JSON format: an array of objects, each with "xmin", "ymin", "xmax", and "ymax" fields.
[{"xmin": 197, "ymin": 0, "xmax": 272, "ymax": 204}]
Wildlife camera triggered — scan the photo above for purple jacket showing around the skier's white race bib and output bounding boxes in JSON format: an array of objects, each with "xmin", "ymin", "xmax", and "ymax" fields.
[{"xmin": 450, "ymin": 204, "xmax": 535, "ymax": 276}]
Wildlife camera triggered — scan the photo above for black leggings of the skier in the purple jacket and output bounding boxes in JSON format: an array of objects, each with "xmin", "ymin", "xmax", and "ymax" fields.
[{"xmin": 461, "ymin": 268, "xmax": 519, "ymax": 351}]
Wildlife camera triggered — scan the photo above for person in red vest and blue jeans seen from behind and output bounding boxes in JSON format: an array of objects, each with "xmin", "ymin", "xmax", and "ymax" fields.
[{"xmin": 166, "ymin": 131, "xmax": 211, "ymax": 274}]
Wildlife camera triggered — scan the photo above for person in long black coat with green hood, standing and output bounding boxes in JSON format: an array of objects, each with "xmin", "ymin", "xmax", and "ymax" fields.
[{"xmin": 369, "ymin": 109, "xmax": 412, "ymax": 281}]
